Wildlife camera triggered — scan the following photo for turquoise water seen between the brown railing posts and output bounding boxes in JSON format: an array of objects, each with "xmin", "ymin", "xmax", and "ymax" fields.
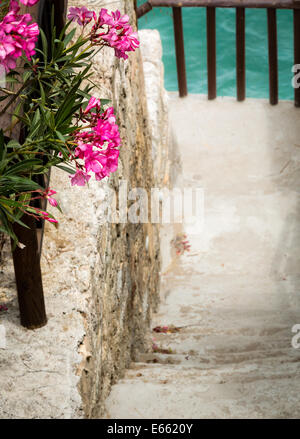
[{"xmin": 138, "ymin": 0, "xmax": 294, "ymax": 99}]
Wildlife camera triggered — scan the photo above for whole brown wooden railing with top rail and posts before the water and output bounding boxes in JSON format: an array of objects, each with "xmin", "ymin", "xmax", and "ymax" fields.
[{"xmin": 137, "ymin": 0, "xmax": 300, "ymax": 107}]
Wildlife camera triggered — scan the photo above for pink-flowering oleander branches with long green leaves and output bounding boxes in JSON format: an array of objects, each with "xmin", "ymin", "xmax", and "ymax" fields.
[{"xmin": 0, "ymin": 0, "xmax": 139, "ymax": 240}]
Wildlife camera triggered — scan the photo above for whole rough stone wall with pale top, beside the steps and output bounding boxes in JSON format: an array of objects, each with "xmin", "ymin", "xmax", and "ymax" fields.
[{"xmin": 0, "ymin": 0, "xmax": 168, "ymax": 418}]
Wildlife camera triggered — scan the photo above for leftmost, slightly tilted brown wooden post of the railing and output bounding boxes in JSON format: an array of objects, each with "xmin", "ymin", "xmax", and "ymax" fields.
[{"xmin": 173, "ymin": 7, "xmax": 187, "ymax": 98}]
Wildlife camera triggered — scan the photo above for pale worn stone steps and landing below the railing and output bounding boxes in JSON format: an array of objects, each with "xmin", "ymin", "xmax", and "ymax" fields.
[{"xmin": 106, "ymin": 95, "xmax": 300, "ymax": 419}]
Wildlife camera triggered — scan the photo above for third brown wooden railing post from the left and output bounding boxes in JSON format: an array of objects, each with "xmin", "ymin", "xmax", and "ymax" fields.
[{"xmin": 236, "ymin": 8, "xmax": 246, "ymax": 101}]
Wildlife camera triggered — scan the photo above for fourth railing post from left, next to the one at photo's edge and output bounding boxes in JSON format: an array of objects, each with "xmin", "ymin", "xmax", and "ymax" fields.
[{"xmin": 267, "ymin": 8, "xmax": 278, "ymax": 105}]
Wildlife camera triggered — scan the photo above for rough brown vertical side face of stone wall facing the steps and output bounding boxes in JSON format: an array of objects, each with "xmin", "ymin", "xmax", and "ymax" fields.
[{"xmin": 56, "ymin": 0, "xmax": 160, "ymax": 417}]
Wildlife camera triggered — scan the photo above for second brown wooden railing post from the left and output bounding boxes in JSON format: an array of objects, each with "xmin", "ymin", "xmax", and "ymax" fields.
[{"xmin": 206, "ymin": 7, "xmax": 217, "ymax": 99}]
